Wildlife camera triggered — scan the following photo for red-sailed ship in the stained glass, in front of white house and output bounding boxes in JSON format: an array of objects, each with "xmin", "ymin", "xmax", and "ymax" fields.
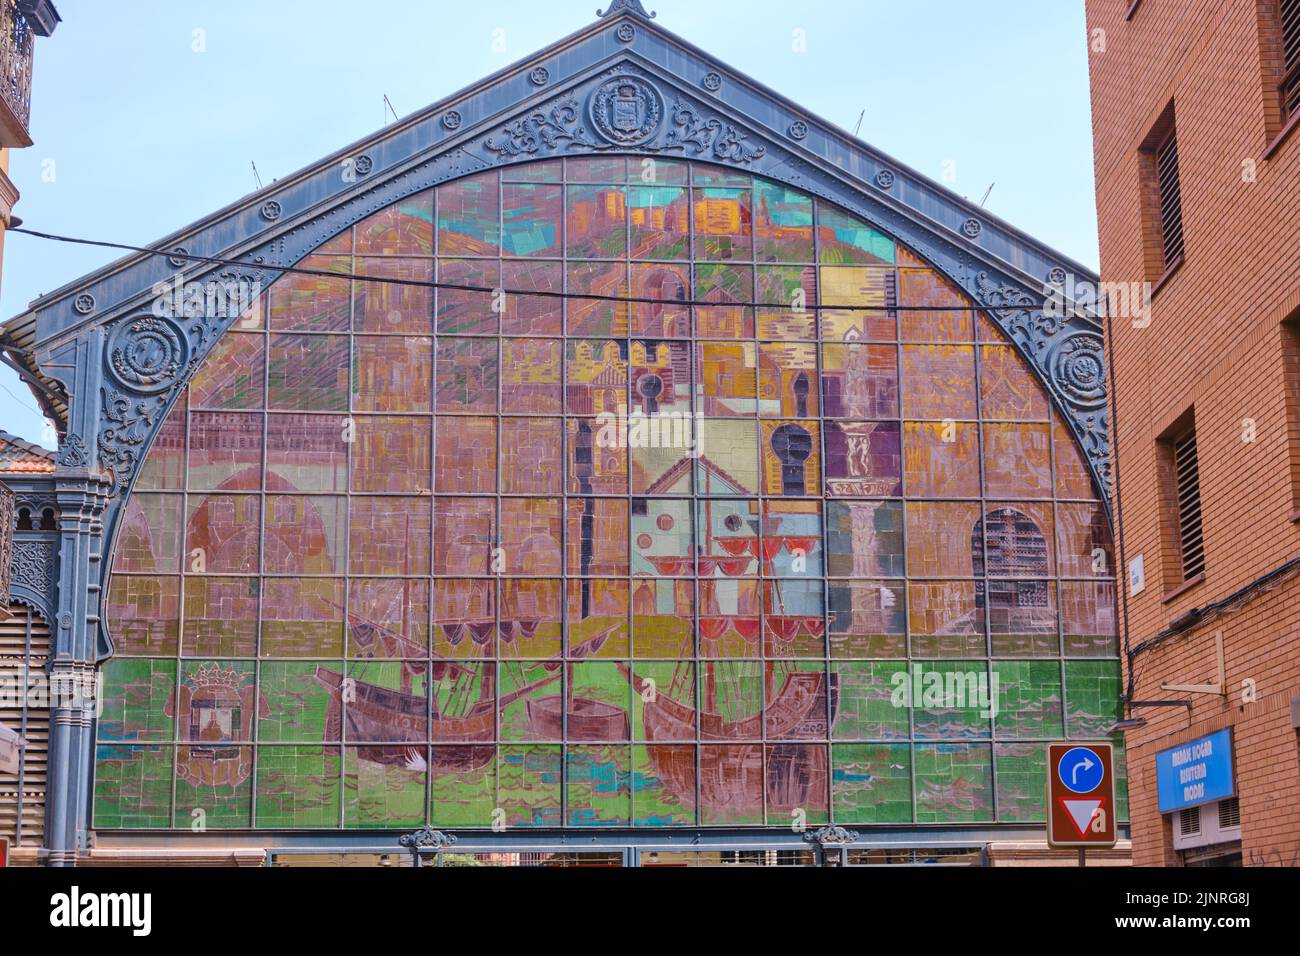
[{"xmin": 624, "ymin": 457, "xmax": 839, "ymax": 816}]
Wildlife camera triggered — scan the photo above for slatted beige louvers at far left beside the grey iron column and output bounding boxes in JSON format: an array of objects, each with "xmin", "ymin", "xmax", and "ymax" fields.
[{"xmin": 0, "ymin": 604, "xmax": 49, "ymax": 848}]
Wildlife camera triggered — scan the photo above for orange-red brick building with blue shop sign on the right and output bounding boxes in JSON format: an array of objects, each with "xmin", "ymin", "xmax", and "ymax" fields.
[{"xmin": 1087, "ymin": 0, "xmax": 1300, "ymax": 865}]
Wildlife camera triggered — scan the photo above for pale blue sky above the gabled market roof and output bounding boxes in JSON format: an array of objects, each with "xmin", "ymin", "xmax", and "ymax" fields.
[{"xmin": 0, "ymin": 0, "xmax": 1097, "ymax": 444}]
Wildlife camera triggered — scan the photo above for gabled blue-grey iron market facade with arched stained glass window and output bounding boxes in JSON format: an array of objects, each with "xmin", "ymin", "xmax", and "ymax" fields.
[{"xmin": 5, "ymin": 0, "xmax": 1126, "ymax": 865}]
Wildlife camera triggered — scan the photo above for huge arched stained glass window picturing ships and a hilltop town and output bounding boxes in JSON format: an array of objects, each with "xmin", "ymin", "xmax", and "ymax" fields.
[{"xmin": 95, "ymin": 156, "xmax": 1119, "ymax": 830}]
